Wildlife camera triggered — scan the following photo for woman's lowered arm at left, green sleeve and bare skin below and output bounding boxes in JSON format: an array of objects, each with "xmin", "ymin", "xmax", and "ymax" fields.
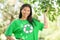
[{"xmin": 5, "ymin": 21, "xmax": 15, "ymax": 40}]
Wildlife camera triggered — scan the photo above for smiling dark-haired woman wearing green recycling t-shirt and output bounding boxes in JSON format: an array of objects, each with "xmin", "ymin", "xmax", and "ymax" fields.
[{"xmin": 5, "ymin": 4, "xmax": 44, "ymax": 40}]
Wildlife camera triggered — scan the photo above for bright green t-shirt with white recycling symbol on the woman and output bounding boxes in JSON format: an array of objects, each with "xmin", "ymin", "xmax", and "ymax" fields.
[{"xmin": 5, "ymin": 18, "xmax": 44, "ymax": 40}]
